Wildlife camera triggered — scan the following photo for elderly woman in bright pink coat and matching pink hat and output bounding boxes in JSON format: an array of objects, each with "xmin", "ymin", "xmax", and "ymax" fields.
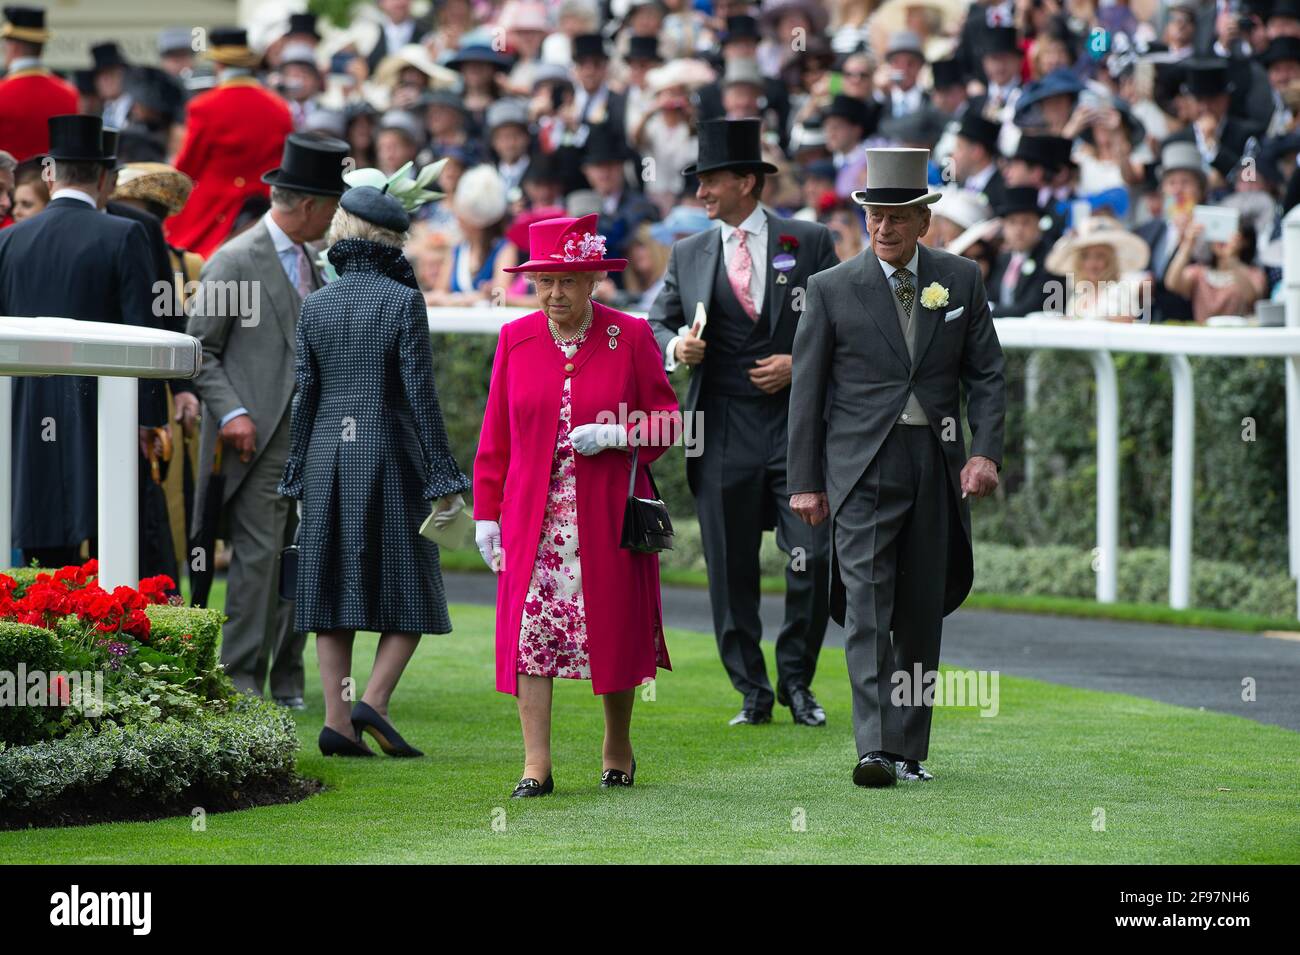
[{"xmin": 473, "ymin": 216, "xmax": 681, "ymax": 798}]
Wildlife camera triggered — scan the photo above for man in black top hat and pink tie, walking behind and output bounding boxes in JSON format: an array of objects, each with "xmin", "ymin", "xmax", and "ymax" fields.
[{"xmin": 650, "ymin": 120, "xmax": 837, "ymax": 726}]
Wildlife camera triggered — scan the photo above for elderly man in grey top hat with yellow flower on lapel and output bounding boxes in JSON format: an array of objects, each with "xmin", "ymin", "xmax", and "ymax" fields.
[{"xmin": 788, "ymin": 149, "xmax": 1006, "ymax": 786}]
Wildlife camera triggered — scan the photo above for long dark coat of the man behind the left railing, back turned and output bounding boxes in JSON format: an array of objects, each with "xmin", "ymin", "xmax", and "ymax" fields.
[{"xmin": 0, "ymin": 197, "xmax": 166, "ymax": 548}]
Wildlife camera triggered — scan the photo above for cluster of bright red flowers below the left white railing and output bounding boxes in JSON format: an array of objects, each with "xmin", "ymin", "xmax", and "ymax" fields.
[{"xmin": 0, "ymin": 560, "xmax": 176, "ymax": 643}]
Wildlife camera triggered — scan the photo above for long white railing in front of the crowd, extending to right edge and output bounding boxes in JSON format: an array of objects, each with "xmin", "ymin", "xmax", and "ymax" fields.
[{"xmin": 429, "ymin": 293, "xmax": 1300, "ymax": 616}]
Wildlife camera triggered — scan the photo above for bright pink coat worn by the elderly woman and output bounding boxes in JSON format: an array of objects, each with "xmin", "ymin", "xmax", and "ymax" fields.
[{"xmin": 473, "ymin": 301, "xmax": 681, "ymax": 694}]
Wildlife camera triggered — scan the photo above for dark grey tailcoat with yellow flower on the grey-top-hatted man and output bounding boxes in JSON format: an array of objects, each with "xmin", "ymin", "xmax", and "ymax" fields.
[{"xmin": 787, "ymin": 246, "xmax": 1006, "ymax": 624}]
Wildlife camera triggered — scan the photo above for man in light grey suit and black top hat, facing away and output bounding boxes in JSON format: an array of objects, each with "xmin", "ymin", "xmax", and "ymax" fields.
[{"xmin": 189, "ymin": 134, "xmax": 348, "ymax": 708}]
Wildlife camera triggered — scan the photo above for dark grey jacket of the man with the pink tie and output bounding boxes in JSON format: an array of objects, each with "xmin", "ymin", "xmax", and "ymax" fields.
[{"xmin": 649, "ymin": 210, "xmax": 839, "ymax": 491}]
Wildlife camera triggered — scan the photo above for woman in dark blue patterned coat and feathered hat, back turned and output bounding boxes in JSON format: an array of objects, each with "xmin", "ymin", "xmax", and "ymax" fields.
[{"xmin": 280, "ymin": 186, "xmax": 469, "ymax": 756}]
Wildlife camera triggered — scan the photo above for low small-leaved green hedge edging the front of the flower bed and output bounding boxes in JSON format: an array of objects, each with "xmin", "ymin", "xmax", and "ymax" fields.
[{"xmin": 0, "ymin": 695, "xmax": 298, "ymax": 808}]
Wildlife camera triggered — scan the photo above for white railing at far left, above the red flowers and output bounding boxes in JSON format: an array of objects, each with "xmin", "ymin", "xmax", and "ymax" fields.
[{"xmin": 0, "ymin": 316, "xmax": 203, "ymax": 590}]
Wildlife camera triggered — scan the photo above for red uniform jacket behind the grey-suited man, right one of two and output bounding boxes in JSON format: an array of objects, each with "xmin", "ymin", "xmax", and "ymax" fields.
[{"xmin": 165, "ymin": 77, "xmax": 294, "ymax": 259}]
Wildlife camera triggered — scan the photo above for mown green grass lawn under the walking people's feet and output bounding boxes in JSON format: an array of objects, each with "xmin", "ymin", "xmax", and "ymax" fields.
[{"xmin": 0, "ymin": 605, "xmax": 1300, "ymax": 864}]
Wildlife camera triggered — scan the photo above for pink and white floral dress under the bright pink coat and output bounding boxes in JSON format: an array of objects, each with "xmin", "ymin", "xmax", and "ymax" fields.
[{"xmin": 517, "ymin": 333, "xmax": 592, "ymax": 680}]
